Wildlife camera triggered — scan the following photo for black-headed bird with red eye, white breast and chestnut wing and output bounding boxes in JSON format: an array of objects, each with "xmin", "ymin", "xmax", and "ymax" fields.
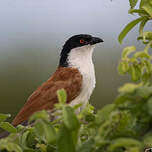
[{"xmin": 12, "ymin": 34, "xmax": 103, "ymax": 127}]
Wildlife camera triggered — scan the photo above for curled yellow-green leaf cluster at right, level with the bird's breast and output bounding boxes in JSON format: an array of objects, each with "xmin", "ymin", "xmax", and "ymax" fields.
[{"xmin": 118, "ymin": 46, "xmax": 152, "ymax": 84}]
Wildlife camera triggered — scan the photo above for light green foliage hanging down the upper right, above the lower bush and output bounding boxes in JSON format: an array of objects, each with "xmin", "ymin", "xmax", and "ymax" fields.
[{"xmin": 118, "ymin": 0, "xmax": 152, "ymax": 84}]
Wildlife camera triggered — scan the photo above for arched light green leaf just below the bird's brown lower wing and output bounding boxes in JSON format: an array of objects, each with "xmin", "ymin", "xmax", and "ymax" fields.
[{"xmin": 29, "ymin": 110, "xmax": 50, "ymax": 122}]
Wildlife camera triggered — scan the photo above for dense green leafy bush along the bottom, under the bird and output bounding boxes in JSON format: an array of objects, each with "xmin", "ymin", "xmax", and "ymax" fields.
[{"xmin": 0, "ymin": 88, "xmax": 152, "ymax": 152}]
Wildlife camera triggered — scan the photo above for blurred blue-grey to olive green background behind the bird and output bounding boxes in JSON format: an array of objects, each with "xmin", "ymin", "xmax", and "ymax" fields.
[{"xmin": 0, "ymin": 0, "xmax": 147, "ymax": 120}]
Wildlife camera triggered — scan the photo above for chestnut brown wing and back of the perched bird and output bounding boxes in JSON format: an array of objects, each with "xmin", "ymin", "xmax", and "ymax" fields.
[{"xmin": 12, "ymin": 67, "xmax": 82, "ymax": 126}]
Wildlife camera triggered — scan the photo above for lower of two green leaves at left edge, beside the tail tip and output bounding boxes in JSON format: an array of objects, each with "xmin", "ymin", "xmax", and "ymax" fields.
[{"xmin": 0, "ymin": 122, "xmax": 17, "ymax": 133}]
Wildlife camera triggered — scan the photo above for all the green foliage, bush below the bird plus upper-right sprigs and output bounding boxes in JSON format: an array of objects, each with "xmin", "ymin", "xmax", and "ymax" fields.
[{"xmin": 0, "ymin": 0, "xmax": 152, "ymax": 152}]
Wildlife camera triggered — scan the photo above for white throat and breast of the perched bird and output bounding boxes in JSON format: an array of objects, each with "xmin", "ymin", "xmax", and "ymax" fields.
[{"xmin": 67, "ymin": 45, "xmax": 96, "ymax": 105}]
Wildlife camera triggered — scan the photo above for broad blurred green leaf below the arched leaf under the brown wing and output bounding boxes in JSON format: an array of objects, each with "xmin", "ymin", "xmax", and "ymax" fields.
[{"xmin": 34, "ymin": 119, "xmax": 56, "ymax": 144}]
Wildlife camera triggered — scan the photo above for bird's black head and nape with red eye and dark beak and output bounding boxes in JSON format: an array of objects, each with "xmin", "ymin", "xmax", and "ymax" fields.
[{"xmin": 59, "ymin": 34, "xmax": 103, "ymax": 67}]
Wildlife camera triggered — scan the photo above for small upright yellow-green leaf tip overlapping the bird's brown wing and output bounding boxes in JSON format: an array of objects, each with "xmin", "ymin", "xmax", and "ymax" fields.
[{"xmin": 57, "ymin": 89, "xmax": 67, "ymax": 104}]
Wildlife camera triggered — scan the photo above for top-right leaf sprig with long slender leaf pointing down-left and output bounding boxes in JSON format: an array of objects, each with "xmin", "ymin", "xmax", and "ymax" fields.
[{"xmin": 118, "ymin": 0, "xmax": 152, "ymax": 45}]
